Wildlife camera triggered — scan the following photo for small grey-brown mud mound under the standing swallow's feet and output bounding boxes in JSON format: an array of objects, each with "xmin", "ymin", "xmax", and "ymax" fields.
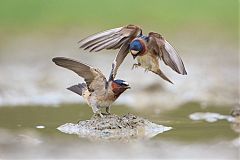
[{"xmin": 57, "ymin": 114, "xmax": 171, "ymax": 139}]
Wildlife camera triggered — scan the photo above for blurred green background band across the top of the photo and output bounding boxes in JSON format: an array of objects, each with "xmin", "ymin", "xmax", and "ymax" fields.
[{"xmin": 0, "ymin": 0, "xmax": 238, "ymax": 34}]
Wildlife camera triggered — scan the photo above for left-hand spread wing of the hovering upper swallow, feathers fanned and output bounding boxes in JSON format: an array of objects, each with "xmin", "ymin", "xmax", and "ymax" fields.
[{"xmin": 79, "ymin": 24, "xmax": 142, "ymax": 52}]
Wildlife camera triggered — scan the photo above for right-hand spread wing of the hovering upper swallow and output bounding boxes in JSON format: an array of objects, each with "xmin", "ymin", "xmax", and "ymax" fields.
[{"xmin": 148, "ymin": 32, "xmax": 187, "ymax": 75}]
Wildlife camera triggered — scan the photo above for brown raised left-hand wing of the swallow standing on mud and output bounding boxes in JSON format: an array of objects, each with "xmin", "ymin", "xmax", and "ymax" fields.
[{"xmin": 52, "ymin": 57, "xmax": 107, "ymax": 91}]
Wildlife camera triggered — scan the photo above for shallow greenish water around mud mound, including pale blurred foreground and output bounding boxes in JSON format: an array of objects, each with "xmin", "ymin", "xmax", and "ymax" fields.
[{"xmin": 0, "ymin": 102, "xmax": 239, "ymax": 159}]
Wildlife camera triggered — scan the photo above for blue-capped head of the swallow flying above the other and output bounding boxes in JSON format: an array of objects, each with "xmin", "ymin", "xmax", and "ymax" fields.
[{"xmin": 129, "ymin": 39, "xmax": 144, "ymax": 59}]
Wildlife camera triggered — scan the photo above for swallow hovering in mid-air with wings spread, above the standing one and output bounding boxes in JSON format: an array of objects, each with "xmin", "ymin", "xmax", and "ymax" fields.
[{"xmin": 79, "ymin": 25, "xmax": 187, "ymax": 83}]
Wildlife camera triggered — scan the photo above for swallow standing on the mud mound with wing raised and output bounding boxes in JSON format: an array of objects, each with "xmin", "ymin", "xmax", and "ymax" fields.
[{"xmin": 52, "ymin": 57, "xmax": 130, "ymax": 117}]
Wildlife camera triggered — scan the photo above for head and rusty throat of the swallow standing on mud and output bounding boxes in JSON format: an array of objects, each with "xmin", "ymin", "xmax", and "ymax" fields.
[{"xmin": 112, "ymin": 79, "xmax": 131, "ymax": 97}]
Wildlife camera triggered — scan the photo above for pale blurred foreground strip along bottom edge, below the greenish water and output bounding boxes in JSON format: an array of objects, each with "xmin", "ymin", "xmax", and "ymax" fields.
[{"xmin": 0, "ymin": 130, "xmax": 238, "ymax": 159}]
